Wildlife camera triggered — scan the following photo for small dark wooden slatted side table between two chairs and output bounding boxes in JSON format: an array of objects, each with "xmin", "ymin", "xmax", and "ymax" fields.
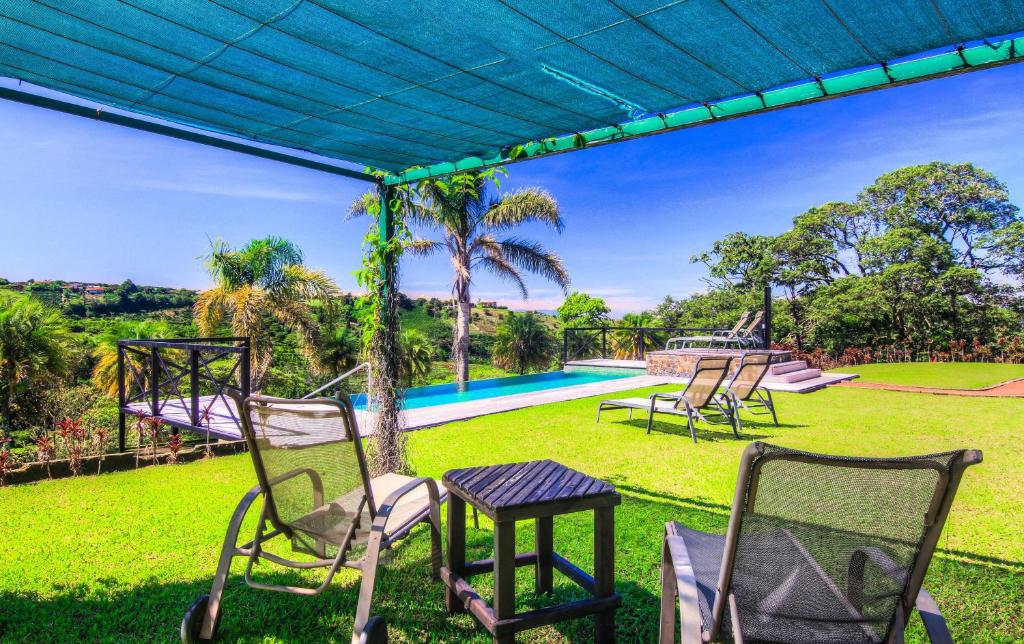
[{"xmin": 441, "ymin": 461, "xmax": 622, "ymax": 642}]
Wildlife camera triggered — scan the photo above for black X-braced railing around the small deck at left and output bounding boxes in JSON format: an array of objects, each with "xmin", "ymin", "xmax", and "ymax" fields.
[{"xmin": 118, "ymin": 338, "xmax": 250, "ymax": 452}]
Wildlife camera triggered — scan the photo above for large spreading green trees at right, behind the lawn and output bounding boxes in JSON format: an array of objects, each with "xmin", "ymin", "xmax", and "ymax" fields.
[{"xmin": 688, "ymin": 162, "xmax": 1024, "ymax": 352}]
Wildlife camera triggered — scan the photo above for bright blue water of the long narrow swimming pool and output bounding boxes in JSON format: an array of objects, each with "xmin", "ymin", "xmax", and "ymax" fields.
[{"xmin": 352, "ymin": 372, "xmax": 636, "ymax": 410}]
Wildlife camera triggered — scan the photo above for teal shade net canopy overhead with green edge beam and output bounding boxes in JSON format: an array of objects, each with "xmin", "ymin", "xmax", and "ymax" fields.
[{"xmin": 0, "ymin": 0, "xmax": 1024, "ymax": 182}]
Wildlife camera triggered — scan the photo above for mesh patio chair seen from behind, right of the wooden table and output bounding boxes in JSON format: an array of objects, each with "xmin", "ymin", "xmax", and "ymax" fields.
[{"xmin": 659, "ymin": 442, "xmax": 981, "ymax": 644}]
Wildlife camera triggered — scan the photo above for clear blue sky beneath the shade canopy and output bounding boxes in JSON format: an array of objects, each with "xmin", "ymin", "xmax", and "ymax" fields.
[{"xmin": 0, "ymin": 66, "xmax": 1024, "ymax": 314}]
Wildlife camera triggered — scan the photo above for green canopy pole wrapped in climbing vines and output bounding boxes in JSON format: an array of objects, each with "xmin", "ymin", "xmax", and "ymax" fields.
[{"xmin": 370, "ymin": 183, "xmax": 408, "ymax": 476}]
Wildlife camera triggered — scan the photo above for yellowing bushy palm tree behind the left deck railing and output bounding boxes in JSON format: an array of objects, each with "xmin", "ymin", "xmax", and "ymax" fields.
[{"xmin": 195, "ymin": 237, "xmax": 338, "ymax": 391}]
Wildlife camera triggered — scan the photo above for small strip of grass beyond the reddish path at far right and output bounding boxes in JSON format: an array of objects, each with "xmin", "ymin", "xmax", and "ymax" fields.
[{"xmin": 835, "ymin": 362, "xmax": 1024, "ymax": 389}]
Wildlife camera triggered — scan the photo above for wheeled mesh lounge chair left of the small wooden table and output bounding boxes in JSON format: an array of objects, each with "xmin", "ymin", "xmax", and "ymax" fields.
[{"xmin": 181, "ymin": 395, "xmax": 446, "ymax": 642}]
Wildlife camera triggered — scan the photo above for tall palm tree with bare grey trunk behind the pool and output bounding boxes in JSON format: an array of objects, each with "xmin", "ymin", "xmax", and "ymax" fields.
[{"xmin": 349, "ymin": 173, "xmax": 569, "ymax": 384}]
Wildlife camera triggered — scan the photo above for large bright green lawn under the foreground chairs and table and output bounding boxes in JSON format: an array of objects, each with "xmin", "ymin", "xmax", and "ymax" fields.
[{"xmin": 0, "ymin": 366, "xmax": 1024, "ymax": 642}]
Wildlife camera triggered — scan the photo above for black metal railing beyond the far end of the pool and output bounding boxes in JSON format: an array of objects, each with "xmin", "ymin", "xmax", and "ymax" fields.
[{"xmin": 562, "ymin": 327, "xmax": 764, "ymax": 362}]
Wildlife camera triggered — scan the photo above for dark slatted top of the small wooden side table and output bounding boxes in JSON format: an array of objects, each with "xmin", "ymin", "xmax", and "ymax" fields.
[{"xmin": 441, "ymin": 460, "xmax": 620, "ymax": 519}]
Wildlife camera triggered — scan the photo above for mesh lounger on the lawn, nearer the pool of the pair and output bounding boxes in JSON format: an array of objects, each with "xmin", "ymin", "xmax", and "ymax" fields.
[{"xmin": 597, "ymin": 356, "xmax": 739, "ymax": 442}]
